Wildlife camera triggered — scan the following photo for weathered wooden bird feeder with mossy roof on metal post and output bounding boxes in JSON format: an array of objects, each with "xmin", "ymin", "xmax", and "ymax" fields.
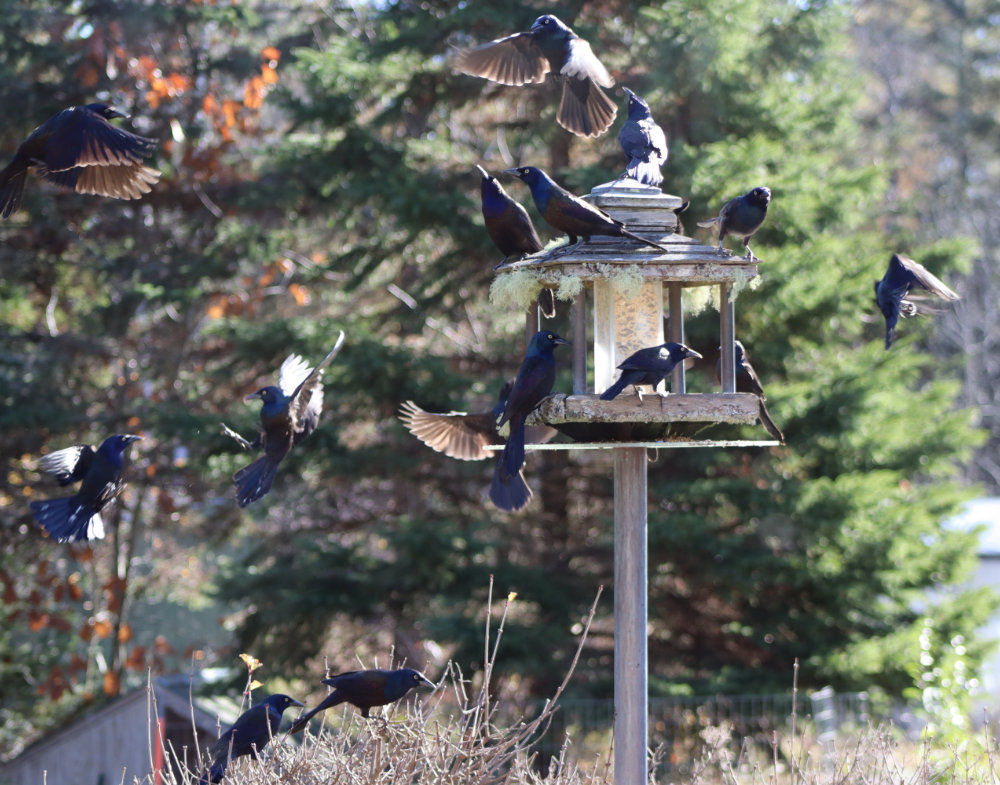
[{"xmin": 494, "ymin": 179, "xmax": 777, "ymax": 785}]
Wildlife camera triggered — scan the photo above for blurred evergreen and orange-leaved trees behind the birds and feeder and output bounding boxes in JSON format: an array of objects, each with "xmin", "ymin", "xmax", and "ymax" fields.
[{"xmin": 0, "ymin": 0, "xmax": 994, "ymax": 752}]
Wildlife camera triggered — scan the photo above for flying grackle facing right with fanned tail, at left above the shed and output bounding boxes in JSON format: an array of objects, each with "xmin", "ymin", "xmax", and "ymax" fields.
[{"xmin": 30, "ymin": 433, "xmax": 142, "ymax": 542}]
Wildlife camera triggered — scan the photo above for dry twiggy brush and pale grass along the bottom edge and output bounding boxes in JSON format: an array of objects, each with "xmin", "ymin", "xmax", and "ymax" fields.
[{"xmin": 145, "ymin": 592, "xmax": 1000, "ymax": 785}]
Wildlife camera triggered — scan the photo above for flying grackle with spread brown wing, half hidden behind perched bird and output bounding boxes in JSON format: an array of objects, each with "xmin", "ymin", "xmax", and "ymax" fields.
[{"xmin": 399, "ymin": 382, "xmax": 555, "ymax": 461}]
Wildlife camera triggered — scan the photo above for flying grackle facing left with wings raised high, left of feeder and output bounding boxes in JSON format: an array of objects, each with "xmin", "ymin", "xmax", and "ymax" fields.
[{"xmin": 222, "ymin": 331, "xmax": 344, "ymax": 507}]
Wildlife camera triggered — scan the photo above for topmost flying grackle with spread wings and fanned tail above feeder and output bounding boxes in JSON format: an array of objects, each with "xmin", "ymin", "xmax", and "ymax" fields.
[{"xmin": 456, "ymin": 14, "xmax": 618, "ymax": 136}]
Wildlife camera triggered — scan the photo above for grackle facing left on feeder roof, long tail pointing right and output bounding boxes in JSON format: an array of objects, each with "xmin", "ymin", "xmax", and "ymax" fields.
[{"xmin": 504, "ymin": 166, "xmax": 669, "ymax": 251}]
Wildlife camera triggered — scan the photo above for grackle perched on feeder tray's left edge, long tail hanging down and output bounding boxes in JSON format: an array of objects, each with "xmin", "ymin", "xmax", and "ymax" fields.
[{"xmin": 490, "ymin": 330, "xmax": 569, "ymax": 510}]
